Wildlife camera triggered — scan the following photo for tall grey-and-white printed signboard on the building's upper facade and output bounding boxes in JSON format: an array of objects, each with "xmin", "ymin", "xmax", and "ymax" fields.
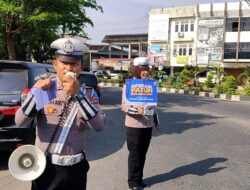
[{"xmin": 197, "ymin": 18, "xmax": 224, "ymax": 64}]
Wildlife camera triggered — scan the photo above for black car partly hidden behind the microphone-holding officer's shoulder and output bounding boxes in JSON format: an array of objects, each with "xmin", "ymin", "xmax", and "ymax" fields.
[{"xmin": 78, "ymin": 71, "xmax": 101, "ymax": 101}]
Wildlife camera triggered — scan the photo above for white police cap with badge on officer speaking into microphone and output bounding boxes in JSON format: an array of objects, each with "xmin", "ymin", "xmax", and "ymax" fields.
[{"xmin": 50, "ymin": 37, "xmax": 89, "ymax": 56}]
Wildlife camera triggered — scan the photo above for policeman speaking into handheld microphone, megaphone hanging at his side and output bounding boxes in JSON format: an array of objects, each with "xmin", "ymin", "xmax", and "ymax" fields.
[{"xmin": 15, "ymin": 37, "xmax": 105, "ymax": 190}]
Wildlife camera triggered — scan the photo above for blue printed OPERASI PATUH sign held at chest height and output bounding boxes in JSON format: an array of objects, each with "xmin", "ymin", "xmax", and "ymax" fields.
[{"xmin": 126, "ymin": 79, "xmax": 157, "ymax": 105}]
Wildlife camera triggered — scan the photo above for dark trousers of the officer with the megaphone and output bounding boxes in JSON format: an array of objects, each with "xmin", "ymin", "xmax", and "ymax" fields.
[{"xmin": 31, "ymin": 156, "xmax": 89, "ymax": 190}]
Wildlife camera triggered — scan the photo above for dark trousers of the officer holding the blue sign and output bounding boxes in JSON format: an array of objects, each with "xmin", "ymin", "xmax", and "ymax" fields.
[{"xmin": 126, "ymin": 127, "xmax": 152, "ymax": 188}]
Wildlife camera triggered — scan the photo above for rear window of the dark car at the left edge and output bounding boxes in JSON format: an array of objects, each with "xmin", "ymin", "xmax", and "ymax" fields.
[{"xmin": 0, "ymin": 68, "xmax": 28, "ymax": 94}]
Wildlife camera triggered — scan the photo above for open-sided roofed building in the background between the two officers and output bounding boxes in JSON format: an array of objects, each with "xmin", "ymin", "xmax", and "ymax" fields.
[{"xmin": 89, "ymin": 34, "xmax": 148, "ymax": 72}]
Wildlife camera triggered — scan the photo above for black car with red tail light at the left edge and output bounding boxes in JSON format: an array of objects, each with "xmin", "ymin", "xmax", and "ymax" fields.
[{"xmin": 0, "ymin": 60, "xmax": 53, "ymax": 150}]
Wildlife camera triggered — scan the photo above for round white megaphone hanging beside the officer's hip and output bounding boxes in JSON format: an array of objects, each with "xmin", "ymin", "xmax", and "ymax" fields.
[{"xmin": 8, "ymin": 145, "xmax": 46, "ymax": 181}]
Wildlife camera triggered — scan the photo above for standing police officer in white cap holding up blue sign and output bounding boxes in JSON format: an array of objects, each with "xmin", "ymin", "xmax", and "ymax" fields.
[{"xmin": 121, "ymin": 57, "xmax": 160, "ymax": 190}]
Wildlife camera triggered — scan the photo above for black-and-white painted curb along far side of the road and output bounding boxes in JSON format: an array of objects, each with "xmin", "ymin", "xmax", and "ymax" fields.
[{"xmin": 99, "ymin": 83, "xmax": 250, "ymax": 102}]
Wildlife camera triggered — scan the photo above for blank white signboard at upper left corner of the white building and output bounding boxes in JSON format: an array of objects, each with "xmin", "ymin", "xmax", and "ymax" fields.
[{"xmin": 148, "ymin": 14, "xmax": 169, "ymax": 41}]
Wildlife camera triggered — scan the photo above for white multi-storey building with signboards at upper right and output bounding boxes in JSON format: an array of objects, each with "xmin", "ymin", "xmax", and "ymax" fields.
[{"xmin": 148, "ymin": 1, "xmax": 250, "ymax": 76}]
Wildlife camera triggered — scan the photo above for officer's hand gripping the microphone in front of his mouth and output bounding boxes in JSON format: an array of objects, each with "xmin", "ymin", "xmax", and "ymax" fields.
[{"xmin": 62, "ymin": 75, "xmax": 80, "ymax": 96}]
